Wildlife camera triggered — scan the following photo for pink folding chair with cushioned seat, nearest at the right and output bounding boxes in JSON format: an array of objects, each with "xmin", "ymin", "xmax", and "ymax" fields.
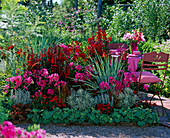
[{"xmin": 136, "ymin": 52, "xmax": 169, "ymax": 114}]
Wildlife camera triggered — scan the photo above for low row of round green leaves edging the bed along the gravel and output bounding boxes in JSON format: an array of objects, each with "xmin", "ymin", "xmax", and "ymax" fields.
[{"xmin": 28, "ymin": 107, "xmax": 159, "ymax": 127}]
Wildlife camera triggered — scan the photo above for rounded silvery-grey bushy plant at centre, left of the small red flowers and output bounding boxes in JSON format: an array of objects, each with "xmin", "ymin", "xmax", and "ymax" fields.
[{"xmin": 67, "ymin": 89, "xmax": 95, "ymax": 111}]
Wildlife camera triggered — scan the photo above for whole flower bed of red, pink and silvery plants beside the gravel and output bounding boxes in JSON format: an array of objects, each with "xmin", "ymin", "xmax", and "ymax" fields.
[{"xmin": 0, "ymin": 26, "xmax": 159, "ymax": 132}]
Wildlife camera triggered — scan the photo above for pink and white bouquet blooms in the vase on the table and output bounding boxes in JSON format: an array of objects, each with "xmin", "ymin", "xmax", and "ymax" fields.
[{"xmin": 123, "ymin": 30, "xmax": 145, "ymax": 42}]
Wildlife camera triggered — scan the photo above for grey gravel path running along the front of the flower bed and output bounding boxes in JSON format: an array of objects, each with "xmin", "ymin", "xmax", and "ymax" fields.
[{"xmin": 15, "ymin": 124, "xmax": 170, "ymax": 138}]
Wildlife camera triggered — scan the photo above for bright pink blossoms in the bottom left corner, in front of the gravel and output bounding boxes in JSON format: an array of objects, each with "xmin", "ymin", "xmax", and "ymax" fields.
[{"xmin": 0, "ymin": 121, "xmax": 46, "ymax": 138}]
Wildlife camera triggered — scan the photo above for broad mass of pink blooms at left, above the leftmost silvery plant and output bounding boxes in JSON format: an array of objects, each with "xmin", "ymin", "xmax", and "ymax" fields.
[{"xmin": 4, "ymin": 68, "xmax": 67, "ymax": 95}]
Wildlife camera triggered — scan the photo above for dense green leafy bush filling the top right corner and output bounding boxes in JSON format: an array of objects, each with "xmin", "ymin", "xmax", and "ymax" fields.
[{"xmin": 133, "ymin": 0, "xmax": 170, "ymax": 40}]
